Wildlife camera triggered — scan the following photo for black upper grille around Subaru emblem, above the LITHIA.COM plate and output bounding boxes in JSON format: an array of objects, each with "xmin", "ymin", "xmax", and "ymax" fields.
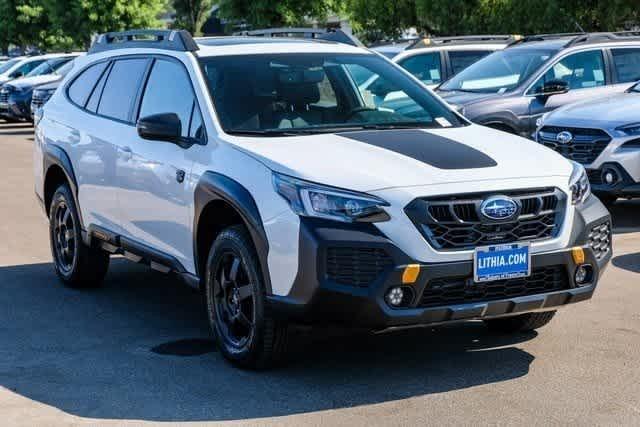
[{"xmin": 405, "ymin": 188, "xmax": 566, "ymax": 250}]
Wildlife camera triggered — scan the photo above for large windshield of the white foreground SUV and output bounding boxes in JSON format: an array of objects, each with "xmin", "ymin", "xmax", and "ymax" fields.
[{"xmin": 200, "ymin": 53, "xmax": 466, "ymax": 135}]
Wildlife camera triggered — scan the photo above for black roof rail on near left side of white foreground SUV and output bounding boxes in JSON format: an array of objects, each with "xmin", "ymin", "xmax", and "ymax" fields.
[{"xmin": 88, "ymin": 30, "xmax": 198, "ymax": 54}]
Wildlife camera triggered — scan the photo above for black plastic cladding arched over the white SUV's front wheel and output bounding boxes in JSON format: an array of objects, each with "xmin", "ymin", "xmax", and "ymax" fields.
[{"xmin": 193, "ymin": 171, "xmax": 272, "ymax": 294}]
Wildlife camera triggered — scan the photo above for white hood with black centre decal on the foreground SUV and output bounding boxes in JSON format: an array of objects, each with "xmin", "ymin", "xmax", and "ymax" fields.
[{"xmin": 230, "ymin": 125, "xmax": 572, "ymax": 191}]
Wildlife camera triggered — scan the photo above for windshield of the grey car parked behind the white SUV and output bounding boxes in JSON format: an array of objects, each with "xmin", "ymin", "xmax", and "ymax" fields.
[{"xmin": 439, "ymin": 49, "xmax": 556, "ymax": 93}]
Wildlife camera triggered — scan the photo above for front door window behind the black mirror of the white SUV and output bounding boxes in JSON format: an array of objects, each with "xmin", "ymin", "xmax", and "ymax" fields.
[{"xmin": 139, "ymin": 59, "xmax": 195, "ymax": 137}]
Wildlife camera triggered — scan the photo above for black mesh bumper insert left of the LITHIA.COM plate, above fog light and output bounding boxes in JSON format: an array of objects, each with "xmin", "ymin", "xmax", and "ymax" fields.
[{"xmin": 327, "ymin": 247, "xmax": 393, "ymax": 288}]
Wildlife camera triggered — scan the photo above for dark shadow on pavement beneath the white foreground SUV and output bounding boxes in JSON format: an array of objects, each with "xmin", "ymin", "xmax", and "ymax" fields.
[{"xmin": 0, "ymin": 259, "xmax": 536, "ymax": 422}]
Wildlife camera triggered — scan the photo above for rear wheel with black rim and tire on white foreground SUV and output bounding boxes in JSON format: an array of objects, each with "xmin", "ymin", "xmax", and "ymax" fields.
[{"xmin": 49, "ymin": 184, "xmax": 109, "ymax": 288}]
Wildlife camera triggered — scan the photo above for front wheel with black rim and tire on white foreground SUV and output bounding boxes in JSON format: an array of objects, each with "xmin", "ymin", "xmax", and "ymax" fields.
[{"xmin": 205, "ymin": 226, "xmax": 288, "ymax": 369}]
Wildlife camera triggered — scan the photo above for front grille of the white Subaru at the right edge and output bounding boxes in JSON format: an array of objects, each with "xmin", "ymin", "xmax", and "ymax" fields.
[{"xmin": 538, "ymin": 126, "xmax": 611, "ymax": 165}]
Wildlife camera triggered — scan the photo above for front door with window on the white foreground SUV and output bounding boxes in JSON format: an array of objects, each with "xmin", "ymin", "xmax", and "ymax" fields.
[{"xmin": 118, "ymin": 56, "xmax": 204, "ymax": 266}]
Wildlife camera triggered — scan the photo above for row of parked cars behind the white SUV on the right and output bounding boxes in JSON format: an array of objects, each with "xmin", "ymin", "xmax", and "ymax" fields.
[{"xmin": 373, "ymin": 32, "xmax": 640, "ymax": 204}]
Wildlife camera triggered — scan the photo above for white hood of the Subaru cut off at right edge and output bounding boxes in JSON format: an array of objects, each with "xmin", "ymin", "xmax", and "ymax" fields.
[{"xmin": 545, "ymin": 92, "xmax": 640, "ymax": 129}]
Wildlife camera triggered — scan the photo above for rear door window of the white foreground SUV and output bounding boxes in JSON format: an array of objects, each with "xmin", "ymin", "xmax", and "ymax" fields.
[{"xmin": 98, "ymin": 58, "xmax": 148, "ymax": 121}]
